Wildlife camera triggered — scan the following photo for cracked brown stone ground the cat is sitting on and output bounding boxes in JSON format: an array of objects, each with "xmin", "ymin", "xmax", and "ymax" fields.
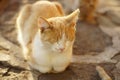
[{"xmin": 0, "ymin": 0, "xmax": 120, "ymax": 80}]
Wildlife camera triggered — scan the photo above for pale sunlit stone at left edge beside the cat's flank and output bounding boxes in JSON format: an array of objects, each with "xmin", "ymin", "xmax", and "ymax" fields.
[{"xmin": 0, "ymin": 36, "xmax": 29, "ymax": 69}]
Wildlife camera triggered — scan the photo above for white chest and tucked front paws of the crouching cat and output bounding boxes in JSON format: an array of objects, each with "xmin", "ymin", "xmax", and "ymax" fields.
[{"xmin": 30, "ymin": 33, "xmax": 72, "ymax": 73}]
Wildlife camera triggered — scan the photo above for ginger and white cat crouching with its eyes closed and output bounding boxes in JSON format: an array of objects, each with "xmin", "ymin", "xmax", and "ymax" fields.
[{"xmin": 17, "ymin": 1, "xmax": 79, "ymax": 73}]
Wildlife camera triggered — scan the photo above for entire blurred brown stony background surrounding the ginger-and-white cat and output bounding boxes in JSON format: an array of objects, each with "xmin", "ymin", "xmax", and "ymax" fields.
[{"xmin": 0, "ymin": 0, "xmax": 120, "ymax": 80}]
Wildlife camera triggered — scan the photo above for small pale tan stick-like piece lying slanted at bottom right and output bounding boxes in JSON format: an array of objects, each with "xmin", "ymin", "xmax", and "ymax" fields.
[{"xmin": 96, "ymin": 66, "xmax": 112, "ymax": 80}]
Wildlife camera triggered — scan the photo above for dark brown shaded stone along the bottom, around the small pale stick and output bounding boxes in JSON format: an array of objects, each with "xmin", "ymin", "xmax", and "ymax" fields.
[{"xmin": 38, "ymin": 63, "xmax": 114, "ymax": 80}]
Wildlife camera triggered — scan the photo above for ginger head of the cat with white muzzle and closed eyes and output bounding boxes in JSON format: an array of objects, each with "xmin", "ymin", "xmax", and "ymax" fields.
[{"xmin": 38, "ymin": 9, "xmax": 79, "ymax": 53}]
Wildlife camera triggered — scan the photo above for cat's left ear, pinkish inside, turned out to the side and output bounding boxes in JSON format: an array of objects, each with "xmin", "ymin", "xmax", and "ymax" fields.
[{"xmin": 38, "ymin": 17, "xmax": 49, "ymax": 32}]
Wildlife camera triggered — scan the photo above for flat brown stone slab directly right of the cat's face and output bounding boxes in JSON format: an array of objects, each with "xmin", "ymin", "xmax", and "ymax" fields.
[{"xmin": 74, "ymin": 21, "xmax": 112, "ymax": 55}]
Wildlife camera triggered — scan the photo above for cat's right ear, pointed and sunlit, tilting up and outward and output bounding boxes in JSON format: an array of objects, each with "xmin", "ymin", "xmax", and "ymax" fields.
[{"xmin": 65, "ymin": 9, "xmax": 80, "ymax": 24}]
